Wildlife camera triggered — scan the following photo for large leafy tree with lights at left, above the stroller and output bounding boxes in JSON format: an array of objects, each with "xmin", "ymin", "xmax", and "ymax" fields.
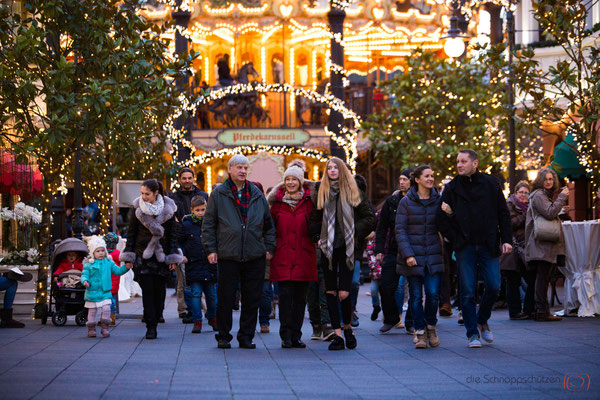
[{"xmin": 0, "ymin": 0, "xmax": 192, "ymax": 315}]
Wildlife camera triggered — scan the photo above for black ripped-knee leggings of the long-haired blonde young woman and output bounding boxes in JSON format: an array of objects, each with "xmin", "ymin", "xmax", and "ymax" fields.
[{"xmin": 323, "ymin": 247, "xmax": 354, "ymax": 329}]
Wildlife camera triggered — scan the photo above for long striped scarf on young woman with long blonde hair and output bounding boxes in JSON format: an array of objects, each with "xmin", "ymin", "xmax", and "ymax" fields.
[{"xmin": 321, "ymin": 181, "xmax": 354, "ymax": 271}]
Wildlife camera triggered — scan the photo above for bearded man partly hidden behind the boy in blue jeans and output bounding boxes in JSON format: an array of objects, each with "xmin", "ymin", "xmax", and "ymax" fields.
[{"xmin": 169, "ymin": 167, "xmax": 208, "ymax": 323}]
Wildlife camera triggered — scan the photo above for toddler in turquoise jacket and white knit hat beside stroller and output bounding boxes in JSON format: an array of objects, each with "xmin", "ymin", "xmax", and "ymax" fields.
[{"xmin": 81, "ymin": 236, "xmax": 127, "ymax": 338}]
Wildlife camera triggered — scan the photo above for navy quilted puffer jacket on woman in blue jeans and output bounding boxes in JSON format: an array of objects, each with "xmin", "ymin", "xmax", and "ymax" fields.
[{"xmin": 396, "ymin": 187, "xmax": 444, "ymax": 276}]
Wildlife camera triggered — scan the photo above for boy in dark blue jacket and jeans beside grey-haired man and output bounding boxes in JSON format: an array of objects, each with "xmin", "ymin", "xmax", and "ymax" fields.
[{"xmin": 180, "ymin": 196, "xmax": 217, "ymax": 333}]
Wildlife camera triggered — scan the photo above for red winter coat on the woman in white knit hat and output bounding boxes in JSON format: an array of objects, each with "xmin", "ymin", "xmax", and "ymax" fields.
[{"xmin": 269, "ymin": 185, "xmax": 317, "ymax": 282}]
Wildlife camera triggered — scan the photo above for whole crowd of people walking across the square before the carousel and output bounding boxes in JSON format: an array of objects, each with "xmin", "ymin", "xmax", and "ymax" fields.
[{"xmin": 2, "ymin": 149, "xmax": 568, "ymax": 350}]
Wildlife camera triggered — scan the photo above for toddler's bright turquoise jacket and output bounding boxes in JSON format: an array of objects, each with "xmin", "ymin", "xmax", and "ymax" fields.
[{"xmin": 81, "ymin": 257, "xmax": 127, "ymax": 302}]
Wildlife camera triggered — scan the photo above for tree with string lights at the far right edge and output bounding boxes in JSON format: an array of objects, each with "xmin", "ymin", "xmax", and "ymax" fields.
[{"xmin": 517, "ymin": 0, "xmax": 600, "ymax": 187}]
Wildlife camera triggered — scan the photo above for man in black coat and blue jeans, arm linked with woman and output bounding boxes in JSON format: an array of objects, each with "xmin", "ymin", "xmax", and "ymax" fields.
[{"xmin": 438, "ymin": 150, "xmax": 512, "ymax": 347}]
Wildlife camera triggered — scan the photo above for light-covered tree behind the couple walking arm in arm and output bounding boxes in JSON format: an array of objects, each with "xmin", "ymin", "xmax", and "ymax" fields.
[{"xmin": 363, "ymin": 45, "xmax": 528, "ymax": 177}]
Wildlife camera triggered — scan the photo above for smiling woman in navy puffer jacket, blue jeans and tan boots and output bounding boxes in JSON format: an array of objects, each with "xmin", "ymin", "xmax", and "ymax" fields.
[{"xmin": 396, "ymin": 165, "xmax": 444, "ymax": 349}]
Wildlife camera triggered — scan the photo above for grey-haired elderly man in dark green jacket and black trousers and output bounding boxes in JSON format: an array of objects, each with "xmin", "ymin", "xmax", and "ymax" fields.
[{"xmin": 202, "ymin": 154, "xmax": 275, "ymax": 349}]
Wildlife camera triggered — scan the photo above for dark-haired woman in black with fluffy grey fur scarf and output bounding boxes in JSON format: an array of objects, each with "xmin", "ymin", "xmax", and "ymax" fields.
[{"xmin": 120, "ymin": 179, "xmax": 183, "ymax": 339}]
